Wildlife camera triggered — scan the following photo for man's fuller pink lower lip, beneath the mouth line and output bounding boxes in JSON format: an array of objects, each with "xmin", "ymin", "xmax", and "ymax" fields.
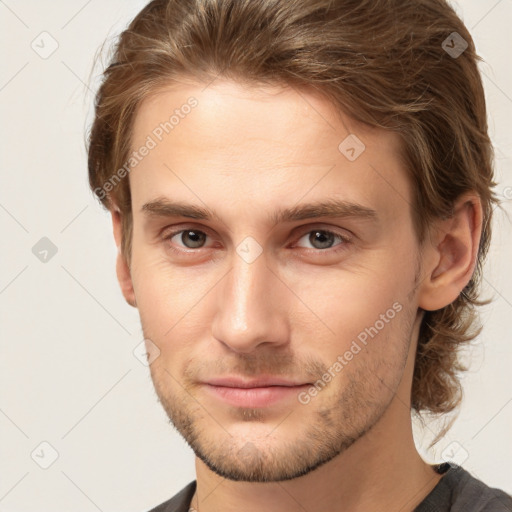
[{"xmin": 205, "ymin": 384, "xmax": 311, "ymax": 407}]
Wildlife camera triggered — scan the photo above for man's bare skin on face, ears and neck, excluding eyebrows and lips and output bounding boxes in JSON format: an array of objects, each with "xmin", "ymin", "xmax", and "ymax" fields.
[{"xmin": 112, "ymin": 79, "xmax": 482, "ymax": 512}]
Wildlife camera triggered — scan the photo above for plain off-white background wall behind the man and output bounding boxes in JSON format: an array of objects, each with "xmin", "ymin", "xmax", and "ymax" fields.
[{"xmin": 0, "ymin": 0, "xmax": 512, "ymax": 512}]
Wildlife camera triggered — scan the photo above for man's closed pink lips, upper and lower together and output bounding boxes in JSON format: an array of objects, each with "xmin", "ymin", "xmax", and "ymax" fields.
[{"xmin": 203, "ymin": 377, "xmax": 311, "ymax": 407}]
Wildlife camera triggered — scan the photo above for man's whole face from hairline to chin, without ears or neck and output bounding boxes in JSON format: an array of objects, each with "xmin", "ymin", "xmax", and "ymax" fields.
[{"xmin": 129, "ymin": 80, "xmax": 418, "ymax": 481}]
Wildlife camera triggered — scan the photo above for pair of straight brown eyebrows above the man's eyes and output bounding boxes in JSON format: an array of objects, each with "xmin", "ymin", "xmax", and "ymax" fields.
[{"xmin": 141, "ymin": 197, "xmax": 378, "ymax": 224}]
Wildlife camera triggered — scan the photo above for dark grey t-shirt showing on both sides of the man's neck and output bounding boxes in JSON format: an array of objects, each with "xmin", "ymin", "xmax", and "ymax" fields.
[{"xmin": 149, "ymin": 462, "xmax": 512, "ymax": 512}]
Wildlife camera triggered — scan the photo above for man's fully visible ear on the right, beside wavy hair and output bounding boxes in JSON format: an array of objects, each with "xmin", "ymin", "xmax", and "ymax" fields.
[{"xmin": 418, "ymin": 192, "xmax": 482, "ymax": 311}]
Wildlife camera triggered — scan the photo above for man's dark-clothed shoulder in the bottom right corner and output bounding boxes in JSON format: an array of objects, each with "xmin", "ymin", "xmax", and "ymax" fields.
[{"xmin": 415, "ymin": 463, "xmax": 512, "ymax": 512}]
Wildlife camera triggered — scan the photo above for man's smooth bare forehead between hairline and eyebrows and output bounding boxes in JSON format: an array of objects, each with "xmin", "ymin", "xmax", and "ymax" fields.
[{"xmin": 129, "ymin": 80, "xmax": 410, "ymax": 222}]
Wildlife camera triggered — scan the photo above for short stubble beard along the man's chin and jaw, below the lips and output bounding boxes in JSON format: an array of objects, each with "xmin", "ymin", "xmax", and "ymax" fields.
[{"xmin": 145, "ymin": 325, "xmax": 411, "ymax": 482}]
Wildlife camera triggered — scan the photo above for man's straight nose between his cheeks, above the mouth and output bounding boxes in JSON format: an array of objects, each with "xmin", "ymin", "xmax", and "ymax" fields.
[{"xmin": 212, "ymin": 246, "xmax": 293, "ymax": 353}]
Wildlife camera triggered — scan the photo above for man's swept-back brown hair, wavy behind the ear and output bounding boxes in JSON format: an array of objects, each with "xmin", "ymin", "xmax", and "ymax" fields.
[{"xmin": 89, "ymin": 0, "xmax": 497, "ymax": 440}]
